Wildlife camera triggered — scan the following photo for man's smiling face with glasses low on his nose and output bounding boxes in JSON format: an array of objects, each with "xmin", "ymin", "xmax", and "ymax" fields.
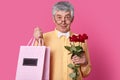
[{"xmin": 54, "ymin": 11, "xmax": 72, "ymax": 33}]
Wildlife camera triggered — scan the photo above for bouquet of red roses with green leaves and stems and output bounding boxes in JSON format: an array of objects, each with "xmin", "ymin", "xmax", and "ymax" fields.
[{"xmin": 65, "ymin": 34, "xmax": 88, "ymax": 80}]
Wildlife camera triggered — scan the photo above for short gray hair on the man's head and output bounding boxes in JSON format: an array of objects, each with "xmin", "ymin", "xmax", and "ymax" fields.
[{"xmin": 52, "ymin": 1, "xmax": 74, "ymax": 18}]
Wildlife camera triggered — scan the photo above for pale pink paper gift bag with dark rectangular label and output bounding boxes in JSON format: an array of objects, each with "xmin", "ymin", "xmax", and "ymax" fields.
[{"xmin": 16, "ymin": 39, "xmax": 50, "ymax": 80}]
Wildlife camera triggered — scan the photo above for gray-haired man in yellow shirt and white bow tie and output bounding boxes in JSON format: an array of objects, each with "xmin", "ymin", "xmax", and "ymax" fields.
[{"xmin": 34, "ymin": 1, "xmax": 91, "ymax": 80}]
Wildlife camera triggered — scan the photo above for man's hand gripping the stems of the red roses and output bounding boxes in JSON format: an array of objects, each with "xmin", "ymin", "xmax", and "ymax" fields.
[{"xmin": 72, "ymin": 55, "xmax": 87, "ymax": 65}]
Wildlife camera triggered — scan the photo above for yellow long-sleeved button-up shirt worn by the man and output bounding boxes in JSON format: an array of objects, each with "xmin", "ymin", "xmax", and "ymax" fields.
[{"xmin": 34, "ymin": 30, "xmax": 91, "ymax": 80}]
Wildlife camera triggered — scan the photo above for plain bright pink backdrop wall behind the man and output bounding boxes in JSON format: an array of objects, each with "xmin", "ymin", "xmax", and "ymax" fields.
[{"xmin": 0, "ymin": 0, "xmax": 120, "ymax": 80}]
